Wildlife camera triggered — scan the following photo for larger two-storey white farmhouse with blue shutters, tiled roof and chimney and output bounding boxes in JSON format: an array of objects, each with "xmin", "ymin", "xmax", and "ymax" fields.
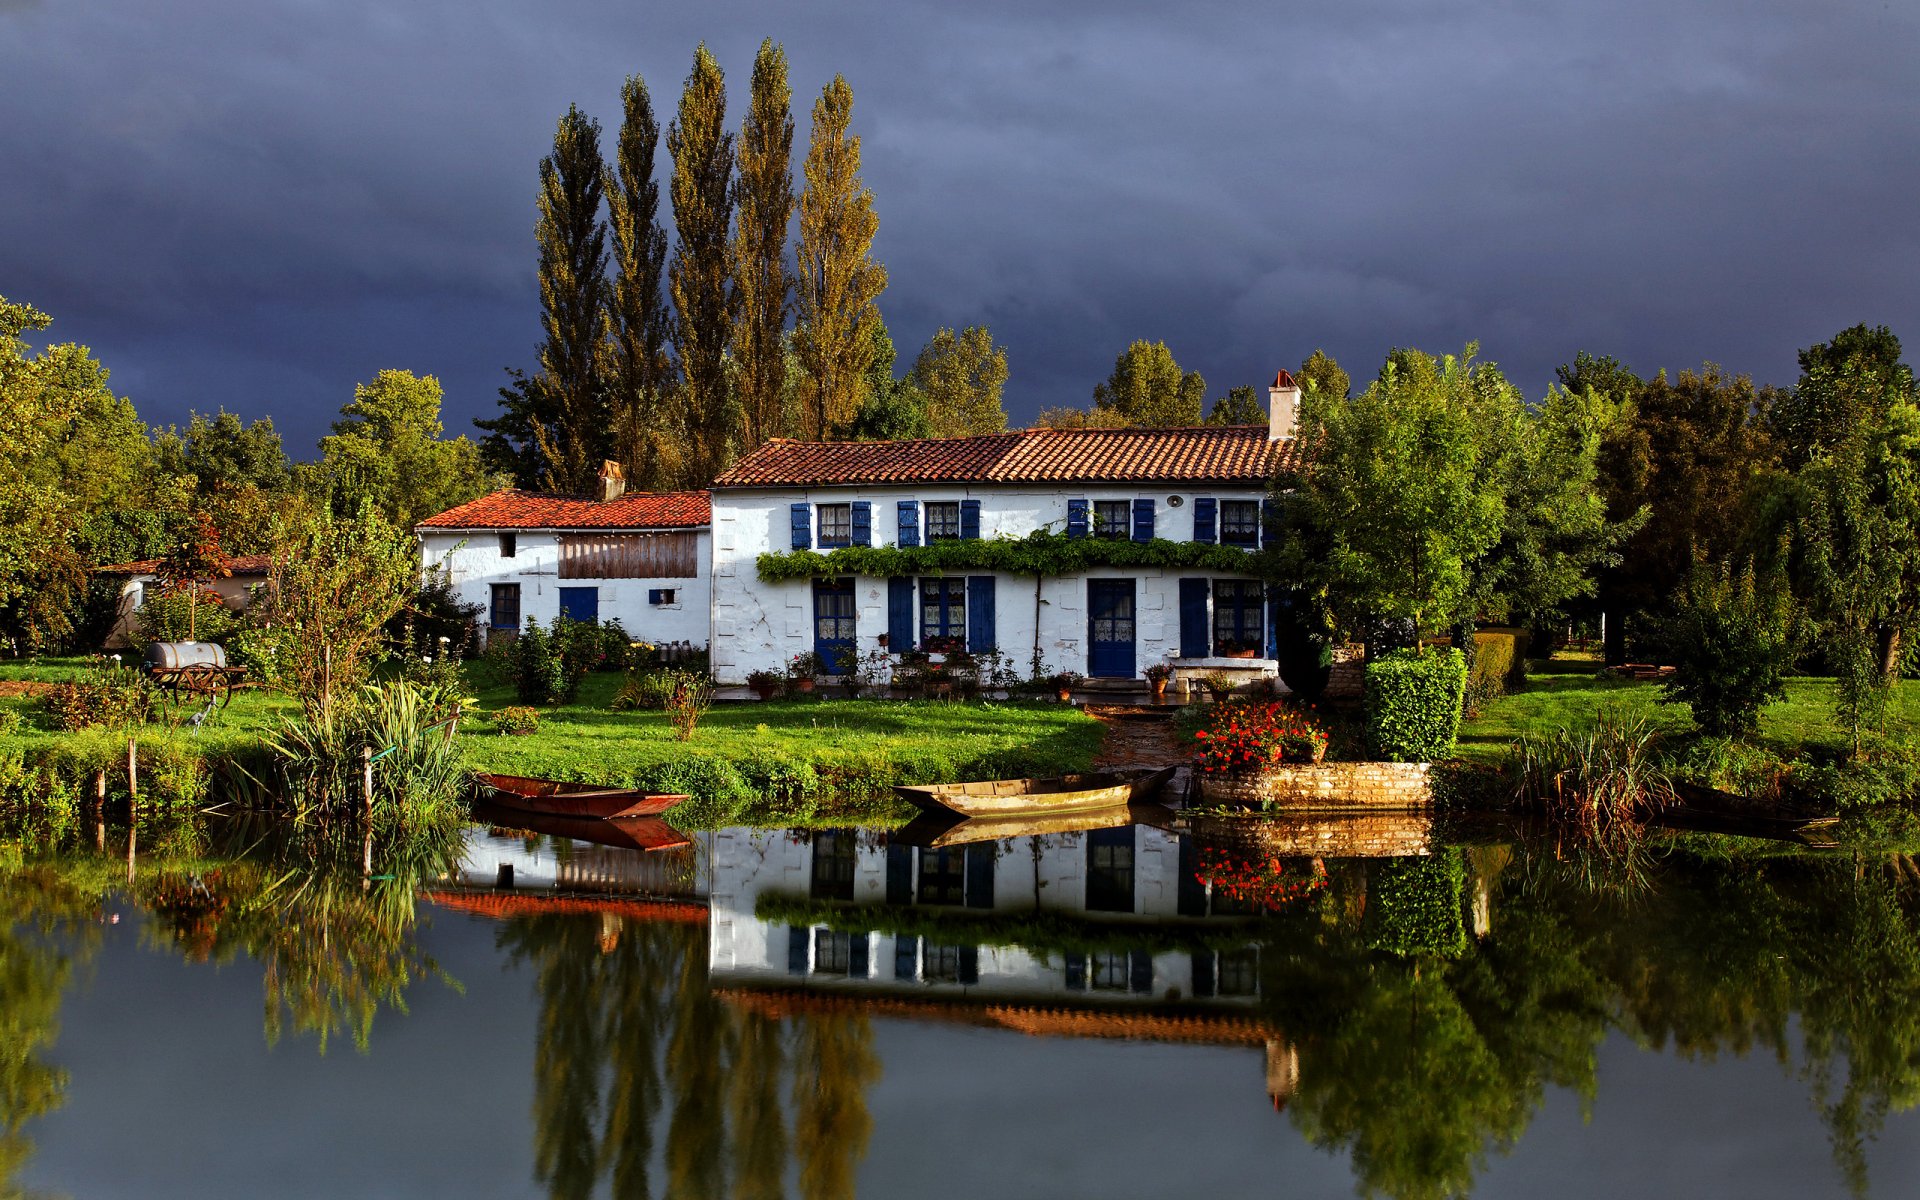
[{"xmin": 712, "ymin": 371, "xmax": 1300, "ymax": 684}]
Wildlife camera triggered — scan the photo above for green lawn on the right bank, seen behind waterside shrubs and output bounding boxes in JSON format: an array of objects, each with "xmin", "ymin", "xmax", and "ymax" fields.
[{"xmin": 1459, "ymin": 660, "xmax": 1920, "ymax": 762}]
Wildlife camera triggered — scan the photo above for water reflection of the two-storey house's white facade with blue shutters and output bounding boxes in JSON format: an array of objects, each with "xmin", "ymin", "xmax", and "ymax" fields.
[{"xmin": 710, "ymin": 826, "xmax": 1260, "ymax": 1004}]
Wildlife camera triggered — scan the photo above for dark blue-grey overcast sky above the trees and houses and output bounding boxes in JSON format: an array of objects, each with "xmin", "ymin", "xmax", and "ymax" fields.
[{"xmin": 0, "ymin": 0, "xmax": 1920, "ymax": 457}]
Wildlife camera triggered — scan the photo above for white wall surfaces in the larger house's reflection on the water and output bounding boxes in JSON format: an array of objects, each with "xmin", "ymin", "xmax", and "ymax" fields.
[{"xmin": 708, "ymin": 826, "xmax": 1254, "ymax": 1006}]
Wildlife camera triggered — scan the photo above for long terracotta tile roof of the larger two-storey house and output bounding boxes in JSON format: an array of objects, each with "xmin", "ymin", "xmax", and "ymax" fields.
[{"xmin": 714, "ymin": 424, "xmax": 1294, "ymax": 488}]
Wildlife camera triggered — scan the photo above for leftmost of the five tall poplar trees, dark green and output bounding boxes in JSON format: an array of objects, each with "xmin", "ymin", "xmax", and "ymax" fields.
[{"xmin": 532, "ymin": 106, "xmax": 607, "ymax": 492}]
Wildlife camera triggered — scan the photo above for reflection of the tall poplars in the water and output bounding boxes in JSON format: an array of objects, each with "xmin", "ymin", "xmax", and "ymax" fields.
[{"xmin": 501, "ymin": 916, "xmax": 879, "ymax": 1200}]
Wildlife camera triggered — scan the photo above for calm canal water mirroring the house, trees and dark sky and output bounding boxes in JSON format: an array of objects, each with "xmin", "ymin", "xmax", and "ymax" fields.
[{"xmin": 0, "ymin": 810, "xmax": 1920, "ymax": 1200}]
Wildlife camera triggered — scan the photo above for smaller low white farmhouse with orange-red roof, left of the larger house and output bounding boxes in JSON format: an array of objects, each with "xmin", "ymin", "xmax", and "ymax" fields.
[{"xmin": 415, "ymin": 463, "xmax": 712, "ymax": 647}]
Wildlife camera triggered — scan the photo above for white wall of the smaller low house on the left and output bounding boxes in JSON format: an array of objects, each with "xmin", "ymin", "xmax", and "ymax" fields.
[{"xmin": 420, "ymin": 530, "xmax": 712, "ymax": 647}]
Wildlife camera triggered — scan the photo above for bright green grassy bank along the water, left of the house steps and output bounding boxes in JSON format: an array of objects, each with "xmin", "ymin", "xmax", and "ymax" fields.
[{"xmin": 0, "ymin": 659, "xmax": 1102, "ymax": 826}]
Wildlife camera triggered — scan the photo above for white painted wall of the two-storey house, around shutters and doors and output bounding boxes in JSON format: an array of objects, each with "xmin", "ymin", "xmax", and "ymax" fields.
[{"xmin": 712, "ymin": 484, "xmax": 1263, "ymax": 684}]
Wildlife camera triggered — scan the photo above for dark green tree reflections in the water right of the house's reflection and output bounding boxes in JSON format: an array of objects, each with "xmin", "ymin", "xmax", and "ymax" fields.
[{"xmin": 1261, "ymin": 854, "xmax": 1920, "ymax": 1196}]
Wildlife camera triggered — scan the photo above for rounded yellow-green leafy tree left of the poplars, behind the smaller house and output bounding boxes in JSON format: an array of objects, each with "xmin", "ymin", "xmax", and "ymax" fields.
[{"xmin": 307, "ymin": 371, "xmax": 497, "ymax": 528}]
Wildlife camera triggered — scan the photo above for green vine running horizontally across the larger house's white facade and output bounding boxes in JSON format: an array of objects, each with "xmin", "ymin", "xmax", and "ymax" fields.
[{"xmin": 756, "ymin": 530, "xmax": 1258, "ymax": 584}]
